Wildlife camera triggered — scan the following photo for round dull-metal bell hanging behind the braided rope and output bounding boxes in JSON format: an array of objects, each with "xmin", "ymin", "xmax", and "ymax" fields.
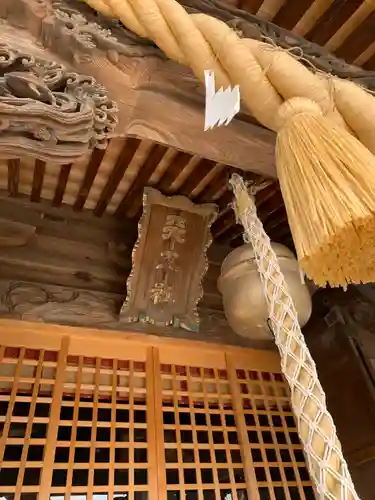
[{"xmin": 218, "ymin": 243, "xmax": 312, "ymax": 340}]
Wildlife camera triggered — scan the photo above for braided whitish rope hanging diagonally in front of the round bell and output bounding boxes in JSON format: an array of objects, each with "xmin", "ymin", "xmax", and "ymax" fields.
[{"xmin": 230, "ymin": 174, "xmax": 359, "ymax": 500}]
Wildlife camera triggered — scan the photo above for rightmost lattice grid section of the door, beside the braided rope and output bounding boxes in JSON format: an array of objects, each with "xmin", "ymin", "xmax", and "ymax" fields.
[{"xmin": 236, "ymin": 370, "xmax": 315, "ymax": 500}]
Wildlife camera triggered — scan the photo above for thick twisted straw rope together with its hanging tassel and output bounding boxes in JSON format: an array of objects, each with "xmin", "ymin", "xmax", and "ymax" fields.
[{"xmin": 83, "ymin": 0, "xmax": 375, "ymax": 292}]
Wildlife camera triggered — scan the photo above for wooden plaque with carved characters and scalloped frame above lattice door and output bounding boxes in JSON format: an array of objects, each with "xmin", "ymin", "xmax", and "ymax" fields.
[{"xmin": 120, "ymin": 188, "xmax": 217, "ymax": 331}]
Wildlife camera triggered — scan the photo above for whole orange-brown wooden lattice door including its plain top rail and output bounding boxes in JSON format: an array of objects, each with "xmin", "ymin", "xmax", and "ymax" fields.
[{"xmin": 0, "ymin": 320, "xmax": 315, "ymax": 500}]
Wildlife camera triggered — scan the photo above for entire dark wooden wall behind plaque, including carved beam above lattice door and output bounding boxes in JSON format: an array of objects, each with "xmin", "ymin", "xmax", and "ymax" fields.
[{"xmin": 0, "ymin": 195, "xmax": 274, "ymax": 347}]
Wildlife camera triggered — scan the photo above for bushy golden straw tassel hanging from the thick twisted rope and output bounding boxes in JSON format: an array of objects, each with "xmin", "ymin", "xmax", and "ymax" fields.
[{"xmin": 276, "ymin": 97, "xmax": 375, "ymax": 286}]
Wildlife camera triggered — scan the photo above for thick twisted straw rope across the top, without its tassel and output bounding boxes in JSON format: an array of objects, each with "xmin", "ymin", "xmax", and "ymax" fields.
[{"xmin": 84, "ymin": 0, "xmax": 375, "ymax": 153}]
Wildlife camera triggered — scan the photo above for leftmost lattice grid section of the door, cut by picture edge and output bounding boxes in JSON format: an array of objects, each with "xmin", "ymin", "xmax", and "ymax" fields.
[{"xmin": 0, "ymin": 346, "xmax": 57, "ymax": 500}]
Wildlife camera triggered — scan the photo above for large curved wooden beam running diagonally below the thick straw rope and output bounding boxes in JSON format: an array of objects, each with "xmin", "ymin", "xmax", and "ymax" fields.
[{"xmin": 0, "ymin": 0, "xmax": 276, "ymax": 178}]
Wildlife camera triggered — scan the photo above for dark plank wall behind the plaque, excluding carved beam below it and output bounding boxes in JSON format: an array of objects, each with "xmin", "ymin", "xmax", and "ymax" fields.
[{"xmin": 0, "ymin": 197, "xmax": 229, "ymax": 310}]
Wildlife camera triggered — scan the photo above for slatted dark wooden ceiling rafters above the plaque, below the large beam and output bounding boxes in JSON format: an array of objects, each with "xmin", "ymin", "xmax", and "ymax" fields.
[{"xmin": 0, "ymin": 138, "xmax": 291, "ymax": 250}]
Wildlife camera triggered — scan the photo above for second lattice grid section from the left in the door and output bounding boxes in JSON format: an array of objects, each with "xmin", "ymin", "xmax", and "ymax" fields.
[{"xmin": 51, "ymin": 356, "xmax": 149, "ymax": 500}]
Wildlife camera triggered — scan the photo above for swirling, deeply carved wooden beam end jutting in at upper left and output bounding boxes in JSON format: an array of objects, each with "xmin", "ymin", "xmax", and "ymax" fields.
[{"xmin": 0, "ymin": 44, "xmax": 117, "ymax": 163}]
